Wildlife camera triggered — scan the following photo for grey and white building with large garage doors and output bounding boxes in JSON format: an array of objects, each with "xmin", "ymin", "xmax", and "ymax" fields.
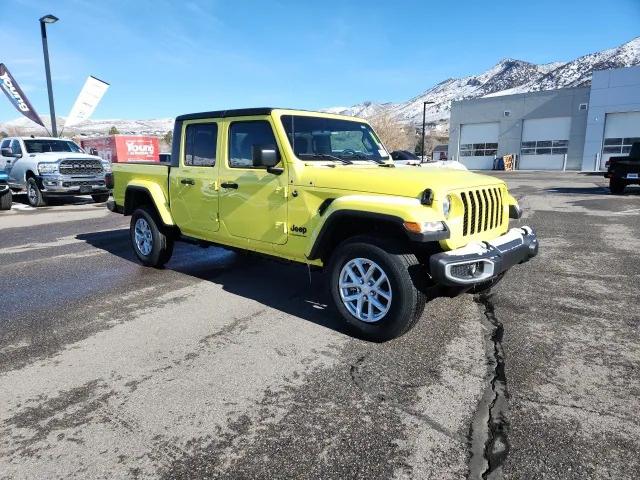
[{"xmin": 449, "ymin": 67, "xmax": 640, "ymax": 171}]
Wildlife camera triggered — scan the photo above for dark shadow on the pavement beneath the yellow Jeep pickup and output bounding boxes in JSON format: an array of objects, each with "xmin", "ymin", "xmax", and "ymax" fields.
[{"xmin": 76, "ymin": 229, "xmax": 353, "ymax": 335}]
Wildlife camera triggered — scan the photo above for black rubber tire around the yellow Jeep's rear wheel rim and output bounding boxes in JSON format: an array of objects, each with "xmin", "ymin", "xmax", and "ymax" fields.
[{"xmin": 129, "ymin": 207, "xmax": 173, "ymax": 268}]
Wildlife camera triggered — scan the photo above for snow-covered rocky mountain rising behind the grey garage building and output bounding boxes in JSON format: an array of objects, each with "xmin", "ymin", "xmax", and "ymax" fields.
[{"xmin": 327, "ymin": 37, "xmax": 640, "ymax": 128}]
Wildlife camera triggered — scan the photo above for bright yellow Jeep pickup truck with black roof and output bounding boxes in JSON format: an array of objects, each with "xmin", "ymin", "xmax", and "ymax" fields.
[{"xmin": 109, "ymin": 108, "xmax": 538, "ymax": 341}]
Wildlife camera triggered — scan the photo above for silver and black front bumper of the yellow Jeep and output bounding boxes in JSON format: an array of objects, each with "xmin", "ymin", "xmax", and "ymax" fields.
[{"xmin": 430, "ymin": 227, "xmax": 538, "ymax": 287}]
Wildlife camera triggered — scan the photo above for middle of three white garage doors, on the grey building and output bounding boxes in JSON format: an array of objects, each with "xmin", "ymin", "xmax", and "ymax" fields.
[{"xmin": 518, "ymin": 117, "xmax": 571, "ymax": 170}]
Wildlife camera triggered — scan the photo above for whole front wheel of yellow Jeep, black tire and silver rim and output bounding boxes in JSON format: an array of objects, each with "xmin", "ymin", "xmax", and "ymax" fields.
[{"xmin": 329, "ymin": 237, "xmax": 426, "ymax": 342}]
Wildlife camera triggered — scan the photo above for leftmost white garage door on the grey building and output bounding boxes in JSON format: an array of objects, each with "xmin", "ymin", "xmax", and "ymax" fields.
[{"xmin": 458, "ymin": 123, "xmax": 500, "ymax": 170}]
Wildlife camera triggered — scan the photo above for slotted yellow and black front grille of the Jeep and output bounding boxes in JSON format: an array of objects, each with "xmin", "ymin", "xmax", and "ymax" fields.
[{"xmin": 460, "ymin": 187, "xmax": 503, "ymax": 235}]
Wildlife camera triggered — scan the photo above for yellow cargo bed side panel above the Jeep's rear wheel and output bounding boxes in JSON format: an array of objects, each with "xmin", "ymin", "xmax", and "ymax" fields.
[{"xmin": 111, "ymin": 162, "xmax": 171, "ymax": 205}]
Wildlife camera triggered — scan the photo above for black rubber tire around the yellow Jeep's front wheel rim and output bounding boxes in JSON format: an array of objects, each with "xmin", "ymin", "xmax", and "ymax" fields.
[{"xmin": 329, "ymin": 236, "xmax": 427, "ymax": 342}]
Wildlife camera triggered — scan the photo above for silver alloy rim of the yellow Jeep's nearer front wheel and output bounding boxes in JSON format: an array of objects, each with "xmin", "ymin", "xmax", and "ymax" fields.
[{"xmin": 338, "ymin": 258, "xmax": 393, "ymax": 323}]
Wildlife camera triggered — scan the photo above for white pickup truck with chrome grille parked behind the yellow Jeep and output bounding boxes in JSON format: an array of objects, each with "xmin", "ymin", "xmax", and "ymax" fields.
[{"xmin": 0, "ymin": 137, "xmax": 111, "ymax": 207}]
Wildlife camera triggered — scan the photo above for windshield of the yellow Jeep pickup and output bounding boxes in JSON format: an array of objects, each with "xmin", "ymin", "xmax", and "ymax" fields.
[{"xmin": 282, "ymin": 115, "xmax": 389, "ymax": 162}]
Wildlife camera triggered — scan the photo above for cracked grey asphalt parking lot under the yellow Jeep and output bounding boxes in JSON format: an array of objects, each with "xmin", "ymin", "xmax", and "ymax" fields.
[{"xmin": 0, "ymin": 173, "xmax": 640, "ymax": 479}]
